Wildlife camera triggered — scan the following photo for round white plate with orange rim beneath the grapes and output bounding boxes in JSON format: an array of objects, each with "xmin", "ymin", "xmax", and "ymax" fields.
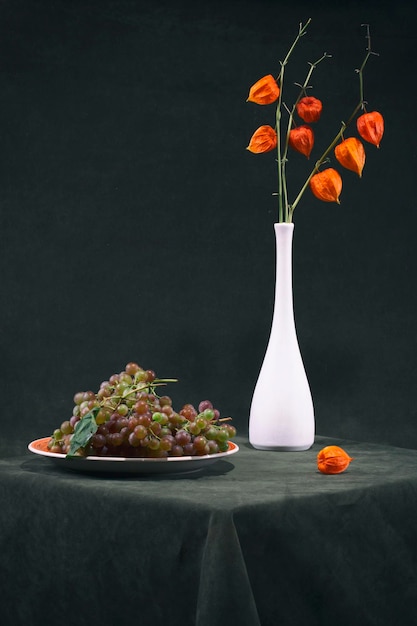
[{"xmin": 28, "ymin": 437, "xmax": 239, "ymax": 474}]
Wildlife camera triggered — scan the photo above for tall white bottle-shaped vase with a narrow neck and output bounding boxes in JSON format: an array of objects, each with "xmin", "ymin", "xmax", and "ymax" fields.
[{"xmin": 249, "ymin": 223, "xmax": 315, "ymax": 451}]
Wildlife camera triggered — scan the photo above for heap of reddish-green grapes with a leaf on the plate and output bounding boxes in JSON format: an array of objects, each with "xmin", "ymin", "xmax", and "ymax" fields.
[{"xmin": 48, "ymin": 363, "xmax": 236, "ymax": 458}]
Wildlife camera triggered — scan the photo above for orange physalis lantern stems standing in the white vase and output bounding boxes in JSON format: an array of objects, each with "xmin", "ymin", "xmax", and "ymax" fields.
[{"xmin": 247, "ymin": 20, "xmax": 384, "ymax": 221}]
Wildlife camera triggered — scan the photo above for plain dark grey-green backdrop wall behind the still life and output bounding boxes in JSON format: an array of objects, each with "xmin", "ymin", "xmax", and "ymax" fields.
[{"xmin": 0, "ymin": 0, "xmax": 417, "ymax": 447}]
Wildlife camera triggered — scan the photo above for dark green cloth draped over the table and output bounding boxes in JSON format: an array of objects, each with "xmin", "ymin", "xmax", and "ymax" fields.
[{"xmin": 0, "ymin": 437, "xmax": 417, "ymax": 626}]
